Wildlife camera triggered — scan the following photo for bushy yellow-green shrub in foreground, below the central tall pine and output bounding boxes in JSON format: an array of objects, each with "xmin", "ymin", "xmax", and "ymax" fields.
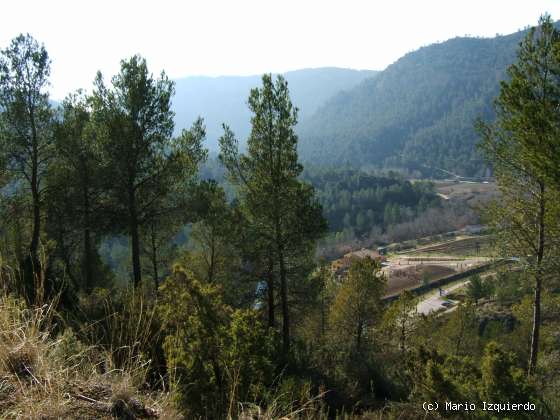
[{"xmin": 160, "ymin": 267, "xmax": 273, "ymax": 417}]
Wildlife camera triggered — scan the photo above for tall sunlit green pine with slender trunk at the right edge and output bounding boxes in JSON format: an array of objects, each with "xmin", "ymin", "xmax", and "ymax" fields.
[{"xmin": 478, "ymin": 16, "xmax": 560, "ymax": 374}]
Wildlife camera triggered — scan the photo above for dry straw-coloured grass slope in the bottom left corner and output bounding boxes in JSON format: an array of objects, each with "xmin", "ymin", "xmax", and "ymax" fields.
[{"xmin": 0, "ymin": 296, "xmax": 173, "ymax": 420}]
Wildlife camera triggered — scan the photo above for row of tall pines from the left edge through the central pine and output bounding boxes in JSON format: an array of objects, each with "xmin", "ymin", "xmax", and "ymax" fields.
[{"xmin": 0, "ymin": 35, "xmax": 326, "ymax": 360}]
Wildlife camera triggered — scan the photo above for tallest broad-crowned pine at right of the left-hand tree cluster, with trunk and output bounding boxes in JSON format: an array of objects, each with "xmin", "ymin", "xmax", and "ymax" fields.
[{"xmin": 93, "ymin": 56, "xmax": 206, "ymax": 286}]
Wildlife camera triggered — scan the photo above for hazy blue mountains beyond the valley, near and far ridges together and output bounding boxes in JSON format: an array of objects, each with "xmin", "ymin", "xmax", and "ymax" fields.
[{"xmin": 173, "ymin": 23, "xmax": 544, "ymax": 178}]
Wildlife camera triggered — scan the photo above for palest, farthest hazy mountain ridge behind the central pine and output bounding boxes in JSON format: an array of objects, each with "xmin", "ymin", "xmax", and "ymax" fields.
[{"xmin": 173, "ymin": 67, "xmax": 376, "ymax": 150}]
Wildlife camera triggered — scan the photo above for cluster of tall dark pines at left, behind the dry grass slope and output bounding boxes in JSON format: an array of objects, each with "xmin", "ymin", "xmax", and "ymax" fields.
[{"xmin": 0, "ymin": 35, "xmax": 206, "ymax": 301}]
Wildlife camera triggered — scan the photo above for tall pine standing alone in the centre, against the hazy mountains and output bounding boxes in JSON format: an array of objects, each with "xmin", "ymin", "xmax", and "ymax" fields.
[{"xmin": 220, "ymin": 75, "xmax": 326, "ymax": 353}]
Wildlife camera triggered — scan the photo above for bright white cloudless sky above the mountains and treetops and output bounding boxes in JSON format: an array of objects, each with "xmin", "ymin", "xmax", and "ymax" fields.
[{"xmin": 0, "ymin": 0, "xmax": 560, "ymax": 99}]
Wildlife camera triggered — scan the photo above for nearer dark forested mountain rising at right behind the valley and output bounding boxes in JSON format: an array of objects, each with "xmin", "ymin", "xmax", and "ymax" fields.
[{"xmin": 299, "ymin": 26, "xmax": 524, "ymax": 176}]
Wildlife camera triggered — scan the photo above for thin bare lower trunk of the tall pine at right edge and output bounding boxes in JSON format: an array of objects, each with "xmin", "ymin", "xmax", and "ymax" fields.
[{"xmin": 527, "ymin": 181, "xmax": 546, "ymax": 376}]
